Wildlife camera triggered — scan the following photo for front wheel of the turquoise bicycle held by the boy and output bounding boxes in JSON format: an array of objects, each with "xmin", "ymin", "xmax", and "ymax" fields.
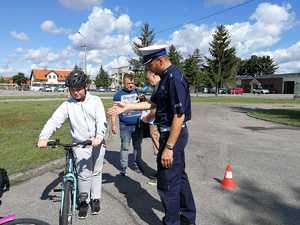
[{"xmin": 59, "ymin": 181, "xmax": 75, "ymax": 225}]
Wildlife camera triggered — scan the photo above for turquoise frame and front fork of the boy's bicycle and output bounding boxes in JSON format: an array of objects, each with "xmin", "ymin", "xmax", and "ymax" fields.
[{"xmin": 60, "ymin": 147, "xmax": 77, "ymax": 214}]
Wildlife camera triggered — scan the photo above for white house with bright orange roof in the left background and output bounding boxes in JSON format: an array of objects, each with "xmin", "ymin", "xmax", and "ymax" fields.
[{"xmin": 30, "ymin": 68, "xmax": 72, "ymax": 89}]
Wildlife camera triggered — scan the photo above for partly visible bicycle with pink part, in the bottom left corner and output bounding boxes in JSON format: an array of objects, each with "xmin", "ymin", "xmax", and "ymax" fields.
[{"xmin": 0, "ymin": 213, "xmax": 50, "ymax": 225}]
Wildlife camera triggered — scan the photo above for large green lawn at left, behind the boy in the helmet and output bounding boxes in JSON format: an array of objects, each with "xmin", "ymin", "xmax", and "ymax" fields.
[{"xmin": 0, "ymin": 100, "xmax": 111, "ymax": 174}]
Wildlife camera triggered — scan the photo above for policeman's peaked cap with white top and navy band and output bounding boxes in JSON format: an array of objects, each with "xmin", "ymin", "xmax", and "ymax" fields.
[{"xmin": 138, "ymin": 45, "xmax": 169, "ymax": 65}]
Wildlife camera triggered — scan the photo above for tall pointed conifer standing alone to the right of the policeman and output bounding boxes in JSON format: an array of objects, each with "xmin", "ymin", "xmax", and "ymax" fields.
[{"xmin": 206, "ymin": 25, "xmax": 238, "ymax": 95}]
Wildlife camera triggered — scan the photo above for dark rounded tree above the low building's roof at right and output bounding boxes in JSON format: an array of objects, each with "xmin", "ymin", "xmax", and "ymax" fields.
[{"xmin": 238, "ymin": 55, "xmax": 278, "ymax": 77}]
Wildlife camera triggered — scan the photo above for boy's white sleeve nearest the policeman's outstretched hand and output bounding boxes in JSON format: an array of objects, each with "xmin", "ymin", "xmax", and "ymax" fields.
[{"xmin": 96, "ymin": 98, "xmax": 107, "ymax": 139}]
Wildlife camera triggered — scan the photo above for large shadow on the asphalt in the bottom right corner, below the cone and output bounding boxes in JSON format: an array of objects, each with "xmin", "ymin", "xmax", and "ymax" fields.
[{"xmin": 217, "ymin": 180, "xmax": 300, "ymax": 225}]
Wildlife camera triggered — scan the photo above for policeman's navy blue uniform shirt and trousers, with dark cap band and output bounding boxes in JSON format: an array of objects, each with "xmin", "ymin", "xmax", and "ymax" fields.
[{"xmin": 143, "ymin": 44, "xmax": 196, "ymax": 225}]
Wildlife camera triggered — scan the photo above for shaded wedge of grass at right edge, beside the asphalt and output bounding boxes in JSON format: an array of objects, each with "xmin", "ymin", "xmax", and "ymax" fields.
[{"xmin": 248, "ymin": 109, "xmax": 300, "ymax": 126}]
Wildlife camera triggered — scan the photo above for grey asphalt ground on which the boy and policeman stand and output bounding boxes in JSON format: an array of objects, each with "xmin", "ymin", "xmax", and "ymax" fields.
[{"xmin": 0, "ymin": 104, "xmax": 300, "ymax": 225}]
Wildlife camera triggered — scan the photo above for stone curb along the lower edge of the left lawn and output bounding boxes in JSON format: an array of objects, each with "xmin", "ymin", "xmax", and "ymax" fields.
[{"xmin": 9, "ymin": 121, "xmax": 112, "ymax": 185}]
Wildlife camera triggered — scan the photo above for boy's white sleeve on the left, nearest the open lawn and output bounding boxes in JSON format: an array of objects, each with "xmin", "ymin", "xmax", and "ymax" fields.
[{"xmin": 39, "ymin": 102, "xmax": 68, "ymax": 139}]
